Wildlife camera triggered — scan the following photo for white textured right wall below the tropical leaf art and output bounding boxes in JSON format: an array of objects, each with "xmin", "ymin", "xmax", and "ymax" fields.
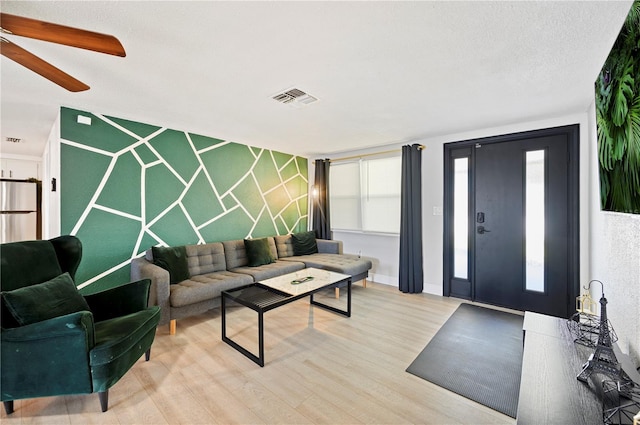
[{"xmin": 584, "ymin": 100, "xmax": 640, "ymax": 365}]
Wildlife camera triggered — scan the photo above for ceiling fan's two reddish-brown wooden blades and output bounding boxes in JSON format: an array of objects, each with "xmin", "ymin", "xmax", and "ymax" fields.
[{"xmin": 0, "ymin": 13, "xmax": 126, "ymax": 92}]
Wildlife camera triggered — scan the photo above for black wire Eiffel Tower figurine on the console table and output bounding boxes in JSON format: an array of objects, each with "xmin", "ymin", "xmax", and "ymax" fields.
[{"xmin": 578, "ymin": 292, "xmax": 631, "ymax": 383}]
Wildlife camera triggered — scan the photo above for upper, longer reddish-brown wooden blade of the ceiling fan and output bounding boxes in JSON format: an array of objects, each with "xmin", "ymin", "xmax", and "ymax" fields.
[{"xmin": 0, "ymin": 13, "xmax": 127, "ymax": 57}]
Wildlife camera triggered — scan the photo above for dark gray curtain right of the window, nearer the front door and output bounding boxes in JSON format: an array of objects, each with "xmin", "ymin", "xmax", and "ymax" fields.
[{"xmin": 398, "ymin": 145, "xmax": 423, "ymax": 293}]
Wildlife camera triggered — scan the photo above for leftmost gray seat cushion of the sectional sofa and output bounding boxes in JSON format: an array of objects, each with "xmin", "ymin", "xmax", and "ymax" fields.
[{"xmin": 169, "ymin": 271, "xmax": 253, "ymax": 307}]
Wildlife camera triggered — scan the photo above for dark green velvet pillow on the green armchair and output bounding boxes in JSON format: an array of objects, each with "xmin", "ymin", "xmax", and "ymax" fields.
[{"xmin": 2, "ymin": 273, "xmax": 91, "ymax": 326}]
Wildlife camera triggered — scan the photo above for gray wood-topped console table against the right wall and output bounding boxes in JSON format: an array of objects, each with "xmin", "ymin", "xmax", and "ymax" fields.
[{"xmin": 517, "ymin": 312, "xmax": 640, "ymax": 425}]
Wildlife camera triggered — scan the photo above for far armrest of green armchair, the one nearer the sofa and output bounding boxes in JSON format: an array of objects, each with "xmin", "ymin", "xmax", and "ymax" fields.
[{"xmin": 84, "ymin": 279, "xmax": 151, "ymax": 322}]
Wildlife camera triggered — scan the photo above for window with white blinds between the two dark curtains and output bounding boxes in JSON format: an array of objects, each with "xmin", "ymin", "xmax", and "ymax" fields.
[{"xmin": 329, "ymin": 156, "xmax": 402, "ymax": 233}]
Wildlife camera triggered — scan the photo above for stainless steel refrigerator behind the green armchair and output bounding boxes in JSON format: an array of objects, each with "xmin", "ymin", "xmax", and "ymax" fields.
[{"xmin": 0, "ymin": 179, "xmax": 42, "ymax": 243}]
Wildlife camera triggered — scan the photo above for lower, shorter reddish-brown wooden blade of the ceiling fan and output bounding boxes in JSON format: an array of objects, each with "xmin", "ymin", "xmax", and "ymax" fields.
[{"xmin": 0, "ymin": 37, "xmax": 89, "ymax": 92}]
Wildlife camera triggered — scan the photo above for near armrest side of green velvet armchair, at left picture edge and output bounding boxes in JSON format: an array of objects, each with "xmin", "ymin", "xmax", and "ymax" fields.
[{"xmin": 0, "ymin": 311, "xmax": 94, "ymax": 401}]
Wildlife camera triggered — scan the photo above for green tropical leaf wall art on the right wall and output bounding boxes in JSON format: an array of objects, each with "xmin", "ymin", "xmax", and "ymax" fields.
[{"xmin": 595, "ymin": 0, "xmax": 640, "ymax": 214}]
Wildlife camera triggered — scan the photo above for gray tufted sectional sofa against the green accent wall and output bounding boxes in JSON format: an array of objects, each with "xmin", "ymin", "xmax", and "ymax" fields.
[{"xmin": 131, "ymin": 235, "xmax": 372, "ymax": 334}]
